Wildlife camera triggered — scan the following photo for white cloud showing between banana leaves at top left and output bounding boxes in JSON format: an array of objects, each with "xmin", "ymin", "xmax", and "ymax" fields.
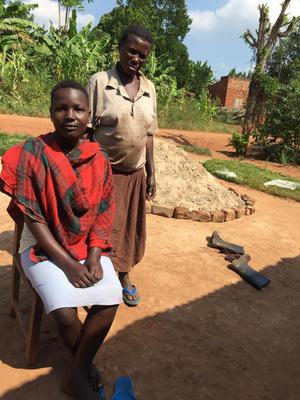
[{"xmin": 24, "ymin": 0, "xmax": 95, "ymax": 28}]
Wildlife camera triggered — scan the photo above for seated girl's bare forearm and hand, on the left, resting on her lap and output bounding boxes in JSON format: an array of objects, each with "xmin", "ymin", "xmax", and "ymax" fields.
[{"xmin": 25, "ymin": 217, "xmax": 98, "ymax": 288}]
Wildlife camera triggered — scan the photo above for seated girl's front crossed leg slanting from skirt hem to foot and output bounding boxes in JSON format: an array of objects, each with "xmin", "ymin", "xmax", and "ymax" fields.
[{"xmin": 62, "ymin": 306, "xmax": 118, "ymax": 400}]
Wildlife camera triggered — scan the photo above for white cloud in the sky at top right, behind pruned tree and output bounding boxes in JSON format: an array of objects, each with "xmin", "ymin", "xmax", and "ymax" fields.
[{"xmin": 189, "ymin": 0, "xmax": 300, "ymax": 37}]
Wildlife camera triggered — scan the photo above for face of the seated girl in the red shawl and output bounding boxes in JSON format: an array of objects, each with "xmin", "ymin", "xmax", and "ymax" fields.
[{"xmin": 50, "ymin": 88, "xmax": 90, "ymax": 142}]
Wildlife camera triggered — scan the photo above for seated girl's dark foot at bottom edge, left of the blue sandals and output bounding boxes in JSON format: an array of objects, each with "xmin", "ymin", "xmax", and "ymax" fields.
[{"xmin": 61, "ymin": 367, "xmax": 99, "ymax": 400}]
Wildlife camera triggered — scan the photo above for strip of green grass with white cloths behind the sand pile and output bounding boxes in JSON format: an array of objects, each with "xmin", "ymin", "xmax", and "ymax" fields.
[{"xmin": 203, "ymin": 159, "xmax": 300, "ymax": 201}]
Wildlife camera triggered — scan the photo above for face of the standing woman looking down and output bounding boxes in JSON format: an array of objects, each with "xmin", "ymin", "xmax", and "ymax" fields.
[{"xmin": 119, "ymin": 33, "xmax": 151, "ymax": 76}]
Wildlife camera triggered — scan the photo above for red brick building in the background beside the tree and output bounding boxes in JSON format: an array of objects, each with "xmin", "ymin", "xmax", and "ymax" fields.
[{"xmin": 208, "ymin": 76, "xmax": 250, "ymax": 110}]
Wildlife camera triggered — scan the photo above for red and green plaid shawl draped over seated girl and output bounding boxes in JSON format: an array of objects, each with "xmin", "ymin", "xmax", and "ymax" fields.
[{"xmin": 0, "ymin": 133, "xmax": 115, "ymax": 261}]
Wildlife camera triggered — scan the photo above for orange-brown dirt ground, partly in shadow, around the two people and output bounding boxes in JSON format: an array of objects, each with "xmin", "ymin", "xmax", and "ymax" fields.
[{"xmin": 0, "ymin": 116, "xmax": 300, "ymax": 400}]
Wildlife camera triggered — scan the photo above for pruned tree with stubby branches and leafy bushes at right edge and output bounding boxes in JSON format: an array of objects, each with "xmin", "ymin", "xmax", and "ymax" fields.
[{"xmin": 239, "ymin": 0, "xmax": 300, "ymax": 164}]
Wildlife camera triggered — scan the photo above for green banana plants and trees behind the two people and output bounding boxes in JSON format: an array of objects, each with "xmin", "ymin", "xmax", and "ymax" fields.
[{"xmin": 0, "ymin": 0, "xmax": 223, "ymax": 125}]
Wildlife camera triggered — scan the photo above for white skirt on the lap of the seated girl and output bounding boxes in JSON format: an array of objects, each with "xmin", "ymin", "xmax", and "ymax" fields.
[{"xmin": 20, "ymin": 248, "xmax": 123, "ymax": 314}]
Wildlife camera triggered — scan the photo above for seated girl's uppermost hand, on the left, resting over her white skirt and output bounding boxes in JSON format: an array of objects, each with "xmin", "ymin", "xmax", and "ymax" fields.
[{"xmin": 63, "ymin": 260, "xmax": 97, "ymax": 288}]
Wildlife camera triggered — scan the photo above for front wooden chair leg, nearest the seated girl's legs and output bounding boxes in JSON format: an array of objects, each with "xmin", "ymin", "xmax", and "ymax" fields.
[{"xmin": 26, "ymin": 294, "xmax": 43, "ymax": 365}]
